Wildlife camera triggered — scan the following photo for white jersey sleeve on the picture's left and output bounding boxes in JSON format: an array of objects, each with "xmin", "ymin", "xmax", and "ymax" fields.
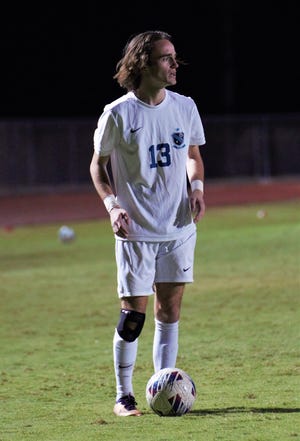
[{"xmin": 93, "ymin": 110, "xmax": 120, "ymax": 156}]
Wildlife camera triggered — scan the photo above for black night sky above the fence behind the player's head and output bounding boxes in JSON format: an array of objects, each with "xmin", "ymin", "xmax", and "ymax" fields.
[{"xmin": 0, "ymin": 0, "xmax": 300, "ymax": 118}]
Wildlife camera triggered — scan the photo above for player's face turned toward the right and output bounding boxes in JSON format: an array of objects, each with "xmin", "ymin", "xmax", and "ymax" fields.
[{"xmin": 147, "ymin": 40, "xmax": 178, "ymax": 88}]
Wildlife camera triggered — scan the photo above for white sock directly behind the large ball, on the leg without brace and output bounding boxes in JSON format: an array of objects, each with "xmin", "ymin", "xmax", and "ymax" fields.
[{"xmin": 153, "ymin": 319, "xmax": 179, "ymax": 372}]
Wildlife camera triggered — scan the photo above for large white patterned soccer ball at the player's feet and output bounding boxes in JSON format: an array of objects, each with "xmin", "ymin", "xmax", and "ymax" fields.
[{"xmin": 146, "ymin": 368, "xmax": 196, "ymax": 416}]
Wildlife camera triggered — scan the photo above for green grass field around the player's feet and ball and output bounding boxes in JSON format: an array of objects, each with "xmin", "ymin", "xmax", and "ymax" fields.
[{"xmin": 0, "ymin": 202, "xmax": 300, "ymax": 441}]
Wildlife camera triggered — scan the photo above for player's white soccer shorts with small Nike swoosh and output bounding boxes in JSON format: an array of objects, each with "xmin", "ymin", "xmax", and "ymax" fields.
[{"xmin": 115, "ymin": 232, "xmax": 197, "ymax": 298}]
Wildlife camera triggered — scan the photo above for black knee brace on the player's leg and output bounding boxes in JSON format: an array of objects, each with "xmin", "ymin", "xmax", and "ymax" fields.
[{"xmin": 117, "ymin": 309, "xmax": 146, "ymax": 342}]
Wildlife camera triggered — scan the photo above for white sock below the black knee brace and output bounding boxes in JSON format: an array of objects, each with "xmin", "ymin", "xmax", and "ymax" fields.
[{"xmin": 113, "ymin": 330, "xmax": 138, "ymax": 400}]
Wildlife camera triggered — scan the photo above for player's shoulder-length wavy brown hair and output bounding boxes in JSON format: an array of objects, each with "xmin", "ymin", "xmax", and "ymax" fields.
[{"xmin": 113, "ymin": 31, "xmax": 172, "ymax": 91}]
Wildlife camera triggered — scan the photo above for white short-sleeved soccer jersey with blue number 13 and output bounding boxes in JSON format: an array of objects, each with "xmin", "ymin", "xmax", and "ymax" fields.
[{"xmin": 94, "ymin": 90, "xmax": 205, "ymax": 242}]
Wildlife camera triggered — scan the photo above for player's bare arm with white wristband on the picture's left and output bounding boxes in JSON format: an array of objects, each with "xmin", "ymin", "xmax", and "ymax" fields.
[{"xmin": 90, "ymin": 152, "xmax": 130, "ymax": 238}]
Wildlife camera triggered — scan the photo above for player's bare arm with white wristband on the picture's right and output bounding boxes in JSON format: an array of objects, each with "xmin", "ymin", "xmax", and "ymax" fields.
[{"xmin": 186, "ymin": 145, "xmax": 205, "ymax": 223}]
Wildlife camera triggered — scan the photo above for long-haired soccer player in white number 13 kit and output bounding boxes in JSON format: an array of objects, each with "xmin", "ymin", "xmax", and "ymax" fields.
[{"xmin": 90, "ymin": 30, "xmax": 205, "ymax": 416}]
